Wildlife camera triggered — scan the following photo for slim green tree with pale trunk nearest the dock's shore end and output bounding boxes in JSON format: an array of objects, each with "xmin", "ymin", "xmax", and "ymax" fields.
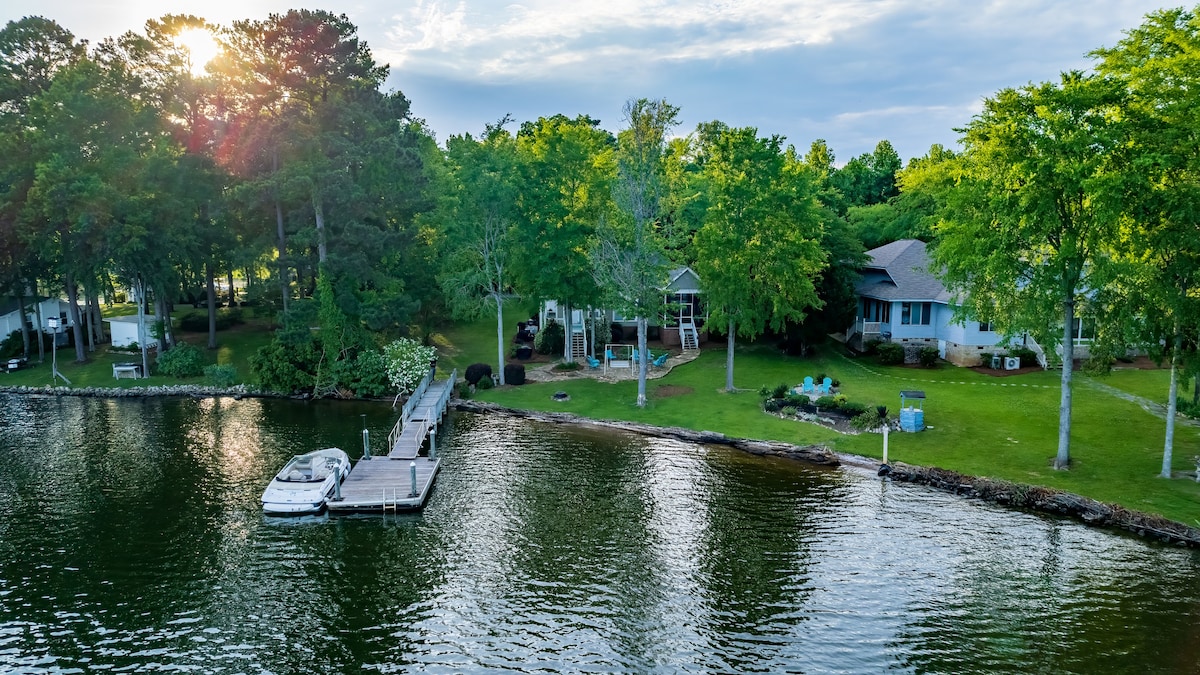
[{"xmin": 438, "ymin": 117, "xmax": 518, "ymax": 384}]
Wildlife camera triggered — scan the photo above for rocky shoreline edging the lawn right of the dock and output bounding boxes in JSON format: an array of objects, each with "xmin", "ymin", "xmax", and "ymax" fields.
[{"xmin": 450, "ymin": 399, "xmax": 1200, "ymax": 548}]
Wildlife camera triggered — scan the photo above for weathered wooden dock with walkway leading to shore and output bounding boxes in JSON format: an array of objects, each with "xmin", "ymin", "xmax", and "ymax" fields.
[{"xmin": 329, "ymin": 370, "xmax": 458, "ymax": 512}]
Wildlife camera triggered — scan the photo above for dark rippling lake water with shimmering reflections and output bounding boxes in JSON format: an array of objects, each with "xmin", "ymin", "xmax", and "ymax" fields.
[{"xmin": 0, "ymin": 396, "xmax": 1200, "ymax": 673}]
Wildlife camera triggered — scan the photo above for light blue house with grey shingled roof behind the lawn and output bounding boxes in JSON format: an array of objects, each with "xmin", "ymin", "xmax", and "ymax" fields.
[{"xmin": 846, "ymin": 239, "xmax": 1003, "ymax": 366}]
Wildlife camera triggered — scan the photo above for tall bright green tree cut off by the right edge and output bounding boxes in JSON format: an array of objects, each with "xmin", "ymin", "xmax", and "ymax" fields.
[{"xmin": 1093, "ymin": 8, "xmax": 1200, "ymax": 478}]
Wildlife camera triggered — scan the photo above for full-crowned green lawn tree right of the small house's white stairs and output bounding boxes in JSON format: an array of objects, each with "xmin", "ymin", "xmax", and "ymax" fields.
[{"xmin": 696, "ymin": 123, "xmax": 826, "ymax": 392}]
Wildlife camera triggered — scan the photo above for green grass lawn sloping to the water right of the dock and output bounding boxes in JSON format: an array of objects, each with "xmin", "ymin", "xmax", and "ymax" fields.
[{"xmin": 442, "ymin": 314, "xmax": 1200, "ymax": 526}]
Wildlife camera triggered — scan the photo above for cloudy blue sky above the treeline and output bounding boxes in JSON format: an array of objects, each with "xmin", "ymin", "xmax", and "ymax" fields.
[{"xmin": 0, "ymin": 0, "xmax": 1182, "ymax": 165}]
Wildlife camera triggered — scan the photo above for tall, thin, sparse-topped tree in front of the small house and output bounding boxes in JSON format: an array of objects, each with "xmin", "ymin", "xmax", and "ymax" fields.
[{"xmin": 593, "ymin": 98, "xmax": 679, "ymax": 407}]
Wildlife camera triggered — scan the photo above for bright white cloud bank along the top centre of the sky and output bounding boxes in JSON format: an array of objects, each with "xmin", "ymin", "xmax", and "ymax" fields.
[{"xmin": 379, "ymin": 0, "xmax": 905, "ymax": 79}]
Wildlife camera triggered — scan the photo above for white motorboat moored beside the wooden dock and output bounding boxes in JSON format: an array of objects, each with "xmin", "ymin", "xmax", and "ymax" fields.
[{"xmin": 263, "ymin": 448, "xmax": 350, "ymax": 515}]
